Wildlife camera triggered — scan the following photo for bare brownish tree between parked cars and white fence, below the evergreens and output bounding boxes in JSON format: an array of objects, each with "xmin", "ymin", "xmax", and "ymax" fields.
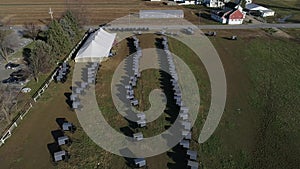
[{"xmin": 28, "ymin": 40, "xmax": 53, "ymax": 81}]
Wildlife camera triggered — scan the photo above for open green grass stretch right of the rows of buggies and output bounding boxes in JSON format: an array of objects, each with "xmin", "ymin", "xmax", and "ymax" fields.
[{"xmin": 201, "ymin": 31, "xmax": 300, "ymax": 169}]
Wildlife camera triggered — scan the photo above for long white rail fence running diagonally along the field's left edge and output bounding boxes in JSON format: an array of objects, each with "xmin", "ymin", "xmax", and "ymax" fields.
[{"xmin": 0, "ymin": 34, "xmax": 88, "ymax": 147}]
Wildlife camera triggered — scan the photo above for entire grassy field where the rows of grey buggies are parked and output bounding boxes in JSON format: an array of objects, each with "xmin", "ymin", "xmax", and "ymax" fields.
[{"xmin": 0, "ymin": 30, "xmax": 300, "ymax": 169}]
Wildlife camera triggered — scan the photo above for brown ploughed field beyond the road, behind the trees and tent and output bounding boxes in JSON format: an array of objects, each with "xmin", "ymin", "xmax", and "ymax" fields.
[{"xmin": 0, "ymin": 0, "xmax": 183, "ymax": 25}]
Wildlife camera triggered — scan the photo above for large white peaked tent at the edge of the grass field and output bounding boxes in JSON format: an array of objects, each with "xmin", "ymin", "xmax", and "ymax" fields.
[{"xmin": 75, "ymin": 28, "xmax": 116, "ymax": 62}]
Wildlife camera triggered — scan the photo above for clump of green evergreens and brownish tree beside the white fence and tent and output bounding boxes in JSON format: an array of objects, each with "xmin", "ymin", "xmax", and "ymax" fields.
[{"xmin": 23, "ymin": 10, "xmax": 81, "ymax": 81}]
